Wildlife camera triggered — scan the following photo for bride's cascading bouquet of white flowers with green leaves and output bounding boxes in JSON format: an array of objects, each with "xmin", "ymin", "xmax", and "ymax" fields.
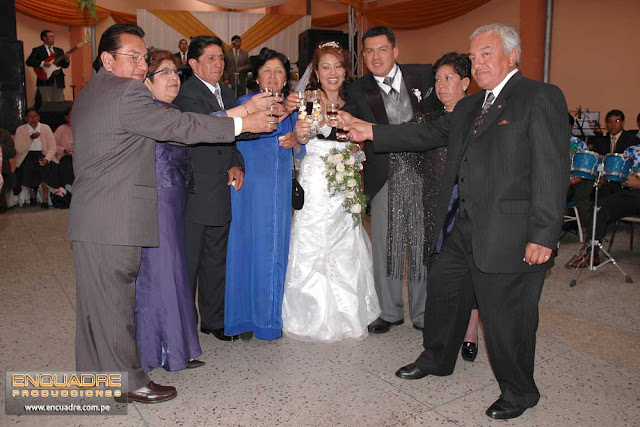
[{"xmin": 322, "ymin": 144, "xmax": 367, "ymax": 225}]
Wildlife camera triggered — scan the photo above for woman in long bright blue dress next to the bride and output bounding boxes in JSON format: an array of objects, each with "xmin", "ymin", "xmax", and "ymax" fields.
[{"xmin": 224, "ymin": 49, "xmax": 305, "ymax": 340}]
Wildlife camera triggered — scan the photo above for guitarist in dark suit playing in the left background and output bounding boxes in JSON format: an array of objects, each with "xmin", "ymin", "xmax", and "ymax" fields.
[{"xmin": 27, "ymin": 30, "xmax": 70, "ymax": 110}]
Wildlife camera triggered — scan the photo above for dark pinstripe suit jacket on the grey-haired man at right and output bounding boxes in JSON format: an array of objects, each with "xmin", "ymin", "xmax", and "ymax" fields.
[{"xmin": 373, "ymin": 72, "xmax": 569, "ymax": 273}]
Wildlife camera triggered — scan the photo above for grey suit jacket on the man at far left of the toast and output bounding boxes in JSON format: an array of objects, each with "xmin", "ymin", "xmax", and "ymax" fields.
[{"xmin": 68, "ymin": 68, "xmax": 235, "ymax": 246}]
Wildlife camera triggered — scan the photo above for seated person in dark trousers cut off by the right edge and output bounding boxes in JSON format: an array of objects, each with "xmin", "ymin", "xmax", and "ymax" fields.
[{"xmin": 571, "ymin": 145, "xmax": 640, "ymax": 268}]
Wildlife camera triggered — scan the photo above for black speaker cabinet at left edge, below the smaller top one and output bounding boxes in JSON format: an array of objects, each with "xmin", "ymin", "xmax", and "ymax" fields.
[{"xmin": 0, "ymin": 39, "xmax": 27, "ymax": 133}]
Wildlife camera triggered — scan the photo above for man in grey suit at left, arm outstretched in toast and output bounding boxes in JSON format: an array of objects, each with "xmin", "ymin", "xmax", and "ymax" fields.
[{"xmin": 69, "ymin": 24, "xmax": 269, "ymax": 403}]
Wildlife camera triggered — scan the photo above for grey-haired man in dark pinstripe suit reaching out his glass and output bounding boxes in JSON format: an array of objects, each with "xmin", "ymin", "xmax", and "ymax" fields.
[{"xmin": 342, "ymin": 24, "xmax": 569, "ymax": 419}]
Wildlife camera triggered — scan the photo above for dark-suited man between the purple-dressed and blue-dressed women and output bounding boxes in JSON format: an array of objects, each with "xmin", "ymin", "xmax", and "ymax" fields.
[{"xmin": 174, "ymin": 36, "xmax": 244, "ymax": 341}]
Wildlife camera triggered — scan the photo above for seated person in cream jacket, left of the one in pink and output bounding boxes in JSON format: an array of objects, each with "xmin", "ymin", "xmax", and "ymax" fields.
[{"xmin": 15, "ymin": 108, "xmax": 58, "ymax": 209}]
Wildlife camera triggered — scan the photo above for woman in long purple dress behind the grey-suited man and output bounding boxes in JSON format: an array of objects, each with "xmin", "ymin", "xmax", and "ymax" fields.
[{"xmin": 136, "ymin": 50, "xmax": 204, "ymax": 371}]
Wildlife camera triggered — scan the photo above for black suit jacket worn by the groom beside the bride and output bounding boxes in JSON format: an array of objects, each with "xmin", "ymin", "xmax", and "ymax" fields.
[{"xmin": 344, "ymin": 64, "xmax": 442, "ymax": 198}]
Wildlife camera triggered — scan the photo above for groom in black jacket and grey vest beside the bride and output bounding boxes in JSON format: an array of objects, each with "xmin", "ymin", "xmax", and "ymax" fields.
[{"xmin": 344, "ymin": 27, "xmax": 439, "ymax": 334}]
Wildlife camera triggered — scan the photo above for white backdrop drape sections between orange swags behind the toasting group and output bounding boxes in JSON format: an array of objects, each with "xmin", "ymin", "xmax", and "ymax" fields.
[{"xmin": 137, "ymin": 9, "xmax": 311, "ymax": 71}]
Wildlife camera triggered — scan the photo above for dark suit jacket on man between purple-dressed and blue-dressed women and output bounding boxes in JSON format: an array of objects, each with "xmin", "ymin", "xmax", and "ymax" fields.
[{"xmin": 174, "ymin": 76, "xmax": 244, "ymax": 226}]
